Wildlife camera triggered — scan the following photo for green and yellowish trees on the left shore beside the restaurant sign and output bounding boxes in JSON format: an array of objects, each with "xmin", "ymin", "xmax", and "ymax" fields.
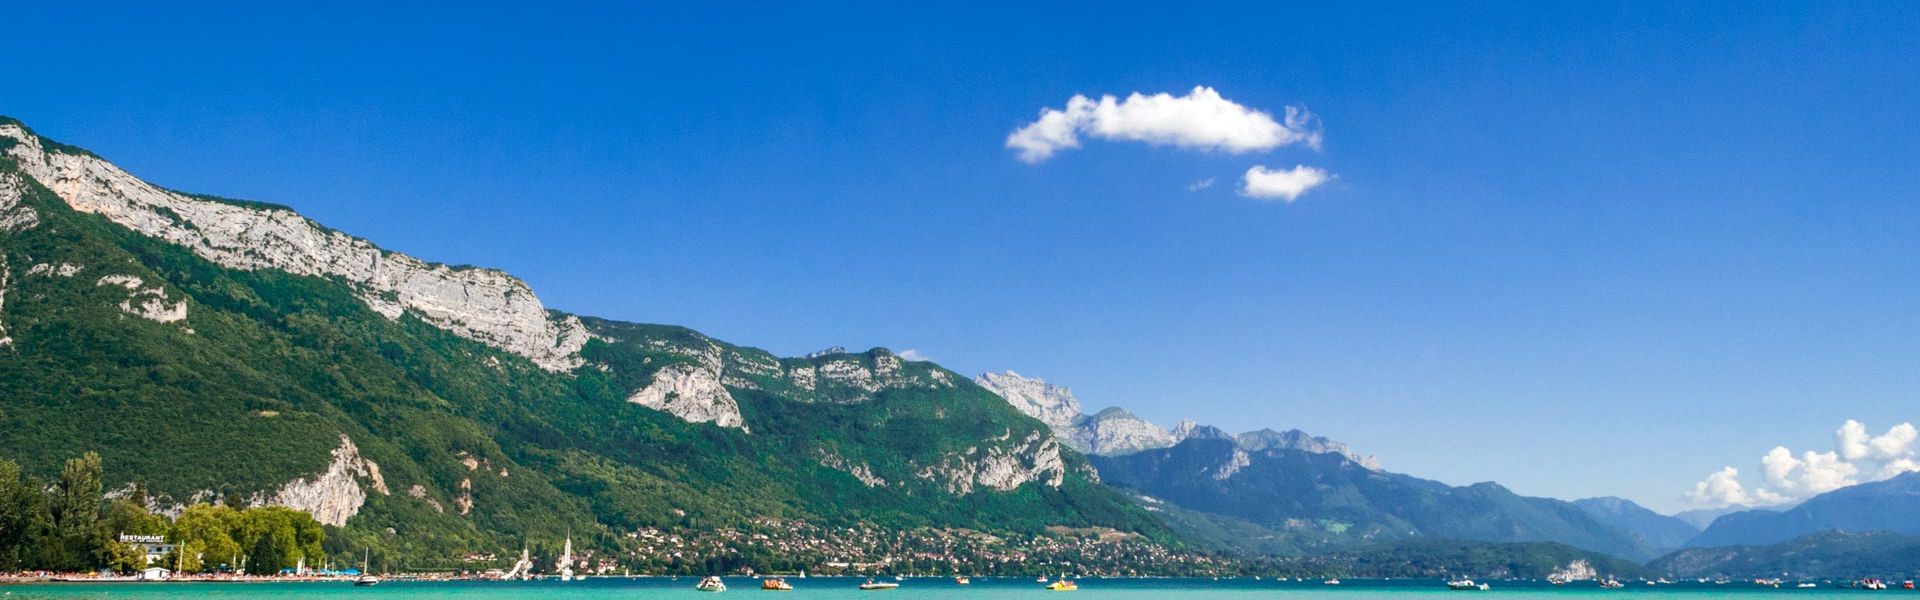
[{"xmin": 0, "ymin": 452, "xmax": 326, "ymax": 575}]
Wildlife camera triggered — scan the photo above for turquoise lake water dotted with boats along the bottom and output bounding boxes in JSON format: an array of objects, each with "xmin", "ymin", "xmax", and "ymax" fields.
[{"xmin": 0, "ymin": 577, "xmax": 1889, "ymax": 600}]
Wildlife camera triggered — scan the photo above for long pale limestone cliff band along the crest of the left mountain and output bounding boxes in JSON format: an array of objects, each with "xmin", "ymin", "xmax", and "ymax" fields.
[{"xmin": 0, "ymin": 123, "xmax": 588, "ymax": 371}]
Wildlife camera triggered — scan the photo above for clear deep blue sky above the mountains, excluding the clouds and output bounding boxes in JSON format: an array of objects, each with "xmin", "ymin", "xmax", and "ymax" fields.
[{"xmin": 0, "ymin": 2, "xmax": 1920, "ymax": 510}]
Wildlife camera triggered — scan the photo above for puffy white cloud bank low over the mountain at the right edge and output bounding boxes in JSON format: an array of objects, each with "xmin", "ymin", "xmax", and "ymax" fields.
[{"xmin": 1686, "ymin": 419, "xmax": 1920, "ymax": 506}]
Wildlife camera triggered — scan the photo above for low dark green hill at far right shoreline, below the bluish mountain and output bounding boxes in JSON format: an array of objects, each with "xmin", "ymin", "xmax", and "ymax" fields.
[{"xmin": 1647, "ymin": 531, "xmax": 1920, "ymax": 579}]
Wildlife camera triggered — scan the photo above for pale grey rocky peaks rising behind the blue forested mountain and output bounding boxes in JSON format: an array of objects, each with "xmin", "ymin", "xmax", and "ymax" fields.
[{"xmin": 973, "ymin": 371, "xmax": 1380, "ymax": 469}]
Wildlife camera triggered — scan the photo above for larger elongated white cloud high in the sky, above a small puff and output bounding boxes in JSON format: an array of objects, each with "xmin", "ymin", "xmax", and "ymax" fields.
[{"xmin": 1006, "ymin": 87, "xmax": 1321, "ymax": 163}]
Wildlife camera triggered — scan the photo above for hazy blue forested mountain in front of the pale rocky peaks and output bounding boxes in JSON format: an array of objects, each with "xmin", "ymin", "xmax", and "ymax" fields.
[{"xmin": 1092, "ymin": 437, "xmax": 1655, "ymax": 558}]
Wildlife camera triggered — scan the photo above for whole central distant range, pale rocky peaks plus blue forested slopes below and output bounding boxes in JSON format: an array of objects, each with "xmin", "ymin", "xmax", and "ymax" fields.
[{"xmin": 973, "ymin": 371, "xmax": 1693, "ymax": 560}]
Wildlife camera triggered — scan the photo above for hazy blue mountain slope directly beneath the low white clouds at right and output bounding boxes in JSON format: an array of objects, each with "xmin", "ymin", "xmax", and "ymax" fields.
[{"xmin": 1688, "ymin": 471, "xmax": 1920, "ymax": 548}]
